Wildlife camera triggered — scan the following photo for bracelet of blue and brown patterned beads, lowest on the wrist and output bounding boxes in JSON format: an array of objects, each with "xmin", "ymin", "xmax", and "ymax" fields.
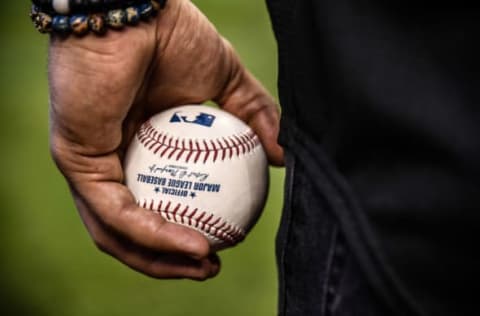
[{"xmin": 30, "ymin": 0, "xmax": 165, "ymax": 36}]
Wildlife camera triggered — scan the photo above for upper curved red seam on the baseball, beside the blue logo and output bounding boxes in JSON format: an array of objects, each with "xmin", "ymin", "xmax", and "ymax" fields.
[{"xmin": 137, "ymin": 120, "xmax": 260, "ymax": 163}]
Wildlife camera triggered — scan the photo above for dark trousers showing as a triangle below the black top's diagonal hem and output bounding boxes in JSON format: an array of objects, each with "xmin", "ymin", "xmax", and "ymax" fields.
[{"xmin": 277, "ymin": 154, "xmax": 392, "ymax": 316}]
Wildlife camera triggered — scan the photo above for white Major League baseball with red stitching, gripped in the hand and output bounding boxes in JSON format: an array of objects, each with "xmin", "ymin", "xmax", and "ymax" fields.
[{"xmin": 124, "ymin": 105, "xmax": 268, "ymax": 251}]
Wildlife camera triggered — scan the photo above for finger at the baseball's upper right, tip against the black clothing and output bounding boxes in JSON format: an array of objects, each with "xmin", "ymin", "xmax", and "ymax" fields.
[{"xmin": 214, "ymin": 40, "xmax": 284, "ymax": 166}]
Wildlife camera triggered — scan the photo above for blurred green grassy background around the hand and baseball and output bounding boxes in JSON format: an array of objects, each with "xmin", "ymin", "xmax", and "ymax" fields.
[{"xmin": 0, "ymin": 0, "xmax": 283, "ymax": 316}]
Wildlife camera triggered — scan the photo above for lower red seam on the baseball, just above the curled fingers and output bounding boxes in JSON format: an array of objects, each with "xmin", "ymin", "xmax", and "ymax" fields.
[{"xmin": 137, "ymin": 199, "xmax": 246, "ymax": 245}]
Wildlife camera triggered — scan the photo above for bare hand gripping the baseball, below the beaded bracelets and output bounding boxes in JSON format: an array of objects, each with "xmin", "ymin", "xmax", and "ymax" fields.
[{"xmin": 49, "ymin": 0, "xmax": 283, "ymax": 280}]
